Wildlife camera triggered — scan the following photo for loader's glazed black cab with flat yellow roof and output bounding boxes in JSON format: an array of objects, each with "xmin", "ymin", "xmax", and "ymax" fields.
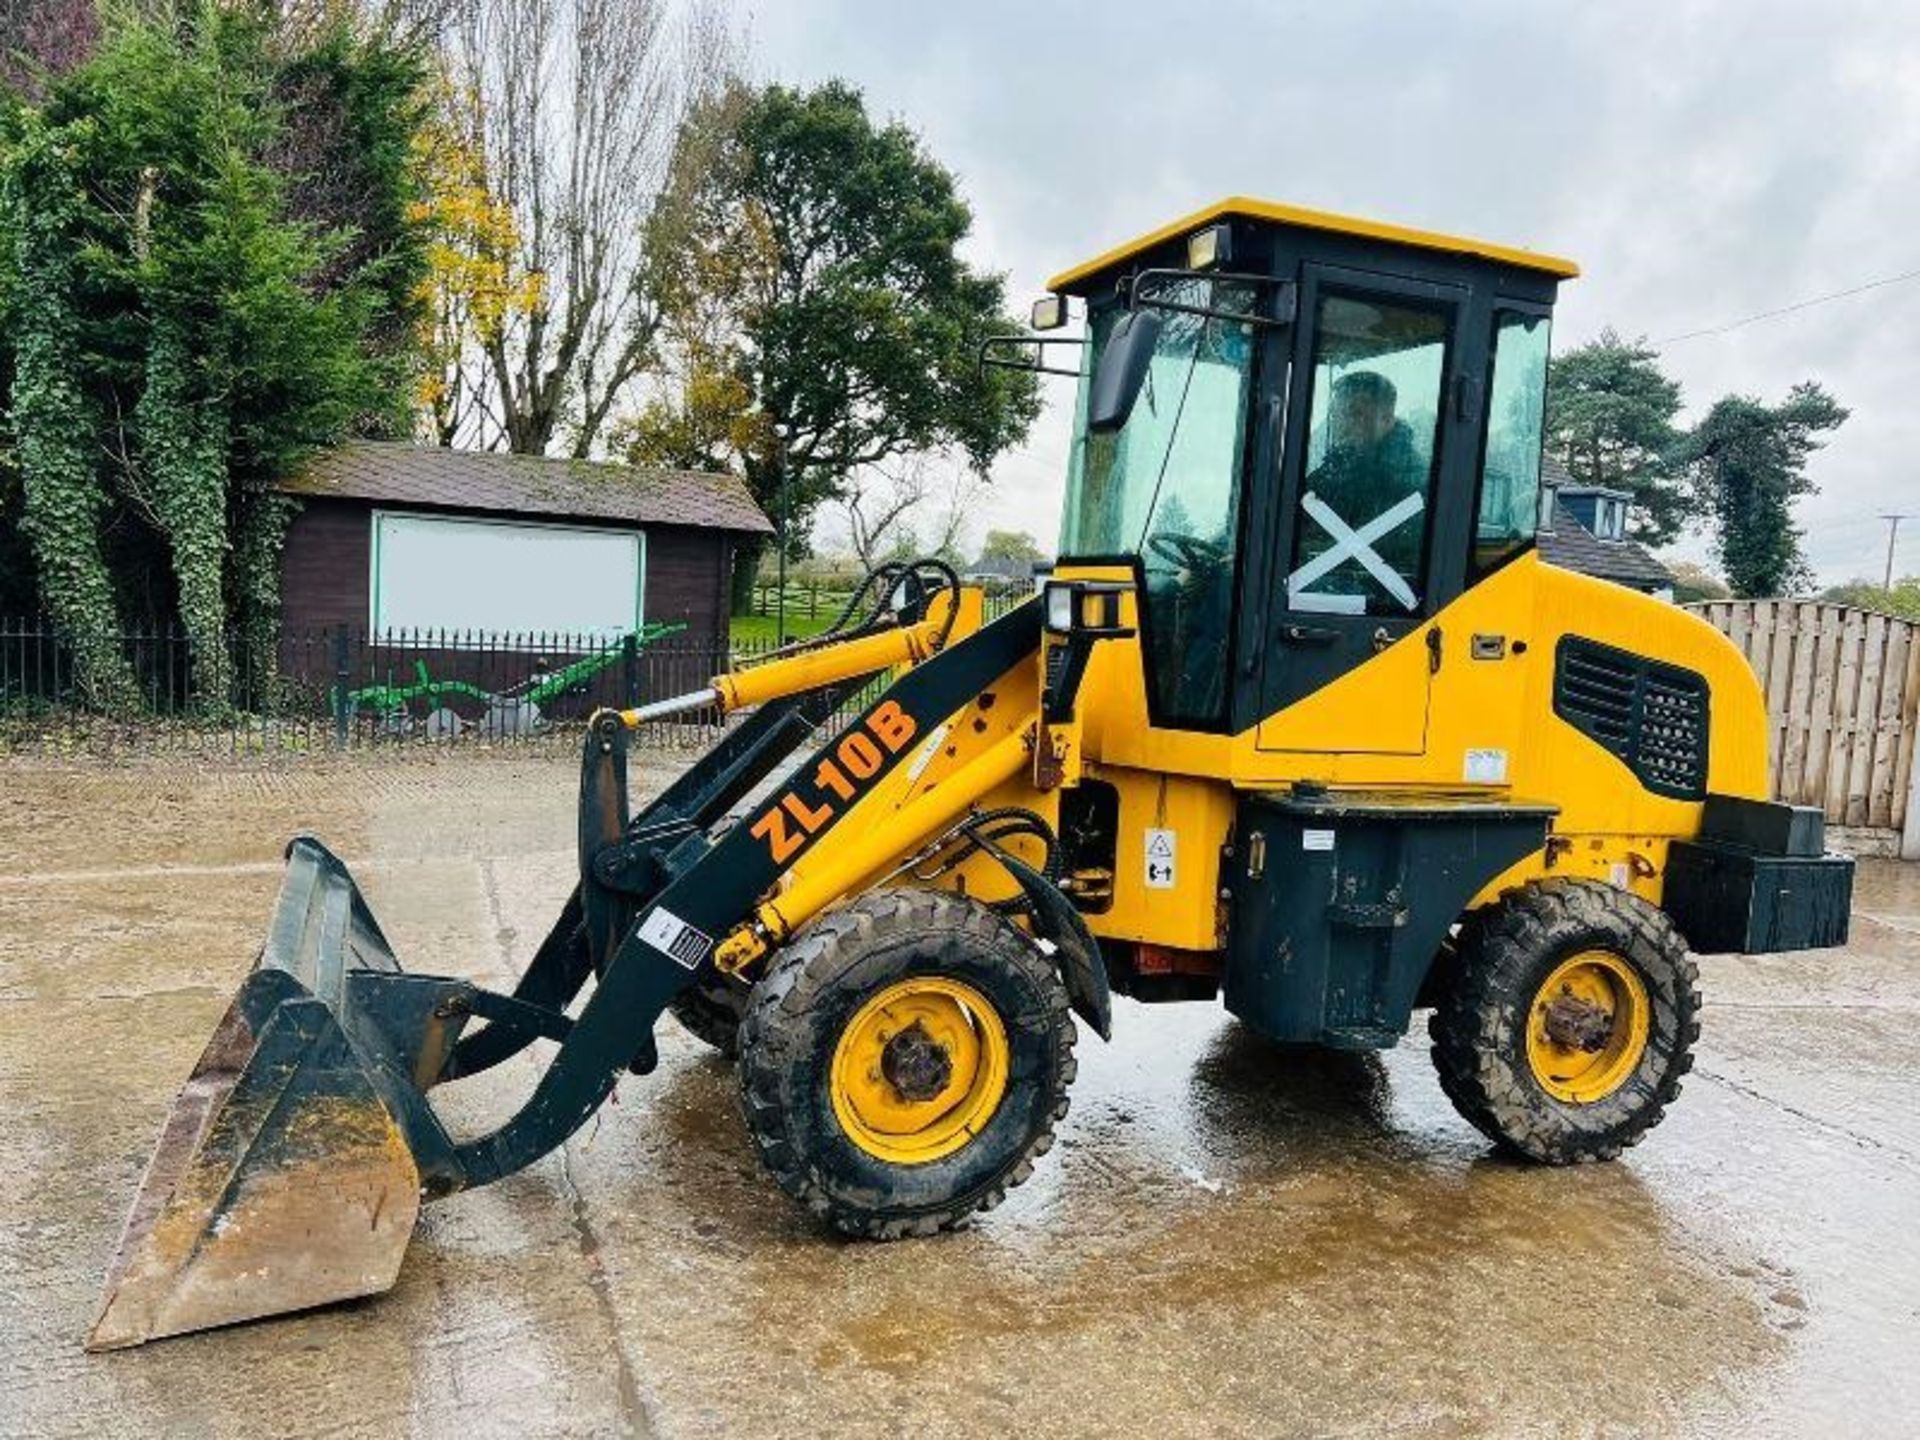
[{"xmin": 1048, "ymin": 200, "xmax": 1576, "ymax": 753}]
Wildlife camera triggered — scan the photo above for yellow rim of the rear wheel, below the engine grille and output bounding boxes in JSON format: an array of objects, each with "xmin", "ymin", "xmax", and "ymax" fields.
[{"xmin": 1526, "ymin": 950, "xmax": 1651, "ymax": 1106}]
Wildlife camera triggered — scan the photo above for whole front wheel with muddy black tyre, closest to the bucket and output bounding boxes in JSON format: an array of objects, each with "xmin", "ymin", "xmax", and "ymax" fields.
[{"xmin": 739, "ymin": 891, "xmax": 1075, "ymax": 1240}]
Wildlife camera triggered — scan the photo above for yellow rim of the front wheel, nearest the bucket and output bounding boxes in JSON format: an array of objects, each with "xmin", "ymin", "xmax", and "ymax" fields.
[{"xmin": 829, "ymin": 975, "xmax": 1008, "ymax": 1165}]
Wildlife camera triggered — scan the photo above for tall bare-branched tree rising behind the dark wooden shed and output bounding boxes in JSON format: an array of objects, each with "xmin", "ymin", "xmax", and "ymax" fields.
[{"xmin": 445, "ymin": 0, "xmax": 735, "ymax": 457}]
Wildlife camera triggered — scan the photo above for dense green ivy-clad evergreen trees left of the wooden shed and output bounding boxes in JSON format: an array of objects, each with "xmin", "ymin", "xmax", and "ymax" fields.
[{"xmin": 0, "ymin": 0, "xmax": 426, "ymax": 708}]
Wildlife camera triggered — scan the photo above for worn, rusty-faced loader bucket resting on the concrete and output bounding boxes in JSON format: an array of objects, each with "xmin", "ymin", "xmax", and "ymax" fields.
[{"xmin": 86, "ymin": 837, "xmax": 465, "ymax": 1350}]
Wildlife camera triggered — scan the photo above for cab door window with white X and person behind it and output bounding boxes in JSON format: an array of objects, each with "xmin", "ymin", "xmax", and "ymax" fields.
[{"xmin": 1286, "ymin": 294, "xmax": 1448, "ymax": 614}]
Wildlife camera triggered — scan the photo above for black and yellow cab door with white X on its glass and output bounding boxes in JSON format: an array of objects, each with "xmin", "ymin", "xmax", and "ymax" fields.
[{"xmin": 1256, "ymin": 265, "xmax": 1484, "ymax": 755}]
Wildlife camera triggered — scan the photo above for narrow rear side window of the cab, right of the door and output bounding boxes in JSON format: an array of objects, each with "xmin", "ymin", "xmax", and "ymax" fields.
[{"xmin": 1473, "ymin": 311, "xmax": 1553, "ymax": 576}]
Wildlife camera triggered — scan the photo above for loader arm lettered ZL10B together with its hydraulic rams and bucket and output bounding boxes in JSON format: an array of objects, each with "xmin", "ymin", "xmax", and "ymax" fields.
[{"xmin": 88, "ymin": 591, "xmax": 1041, "ymax": 1348}]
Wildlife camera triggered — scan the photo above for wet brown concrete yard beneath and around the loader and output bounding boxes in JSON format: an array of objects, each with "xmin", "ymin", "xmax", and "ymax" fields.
[{"xmin": 0, "ymin": 758, "xmax": 1920, "ymax": 1440}]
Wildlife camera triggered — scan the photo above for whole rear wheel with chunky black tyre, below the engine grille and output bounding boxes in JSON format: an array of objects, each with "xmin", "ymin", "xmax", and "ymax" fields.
[{"xmin": 1428, "ymin": 879, "xmax": 1699, "ymax": 1165}]
